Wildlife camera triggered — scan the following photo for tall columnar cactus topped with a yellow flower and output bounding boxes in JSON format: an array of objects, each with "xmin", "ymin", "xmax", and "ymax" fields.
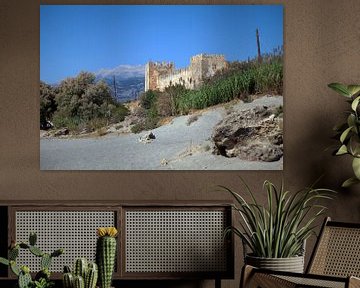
[{"xmin": 96, "ymin": 227, "xmax": 117, "ymax": 288}]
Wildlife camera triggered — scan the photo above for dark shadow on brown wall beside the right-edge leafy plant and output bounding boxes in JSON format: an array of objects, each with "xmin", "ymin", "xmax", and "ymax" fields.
[{"xmin": 296, "ymin": 108, "xmax": 360, "ymax": 222}]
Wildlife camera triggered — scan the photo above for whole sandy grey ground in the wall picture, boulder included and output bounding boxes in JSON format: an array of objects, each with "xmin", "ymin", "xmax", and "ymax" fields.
[{"xmin": 40, "ymin": 96, "xmax": 283, "ymax": 170}]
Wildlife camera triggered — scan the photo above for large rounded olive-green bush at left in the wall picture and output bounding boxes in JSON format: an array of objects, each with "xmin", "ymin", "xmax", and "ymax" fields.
[{"xmin": 40, "ymin": 72, "xmax": 129, "ymax": 132}]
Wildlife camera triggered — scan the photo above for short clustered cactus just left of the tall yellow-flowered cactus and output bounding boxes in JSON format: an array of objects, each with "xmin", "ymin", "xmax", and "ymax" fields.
[{"xmin": 63, "ymin": 258, "xmax": 98, "ymax": 288}]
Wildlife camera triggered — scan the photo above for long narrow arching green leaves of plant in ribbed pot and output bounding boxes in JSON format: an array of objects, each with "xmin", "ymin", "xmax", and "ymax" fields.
[{"xmin": 220, "ymin": 179, "xmax": 334, "ymax": 258}]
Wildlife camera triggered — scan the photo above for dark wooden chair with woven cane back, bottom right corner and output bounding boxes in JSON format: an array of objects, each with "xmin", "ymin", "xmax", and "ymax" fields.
[{"xmin": 240, "ymin": 218, "xmax": 360, "ymax": 288}]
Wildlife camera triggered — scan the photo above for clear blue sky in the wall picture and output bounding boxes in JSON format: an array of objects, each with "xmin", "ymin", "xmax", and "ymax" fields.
[{"xmin": 40, "ymin": 5, "xmax": 283, "ymax": 83}]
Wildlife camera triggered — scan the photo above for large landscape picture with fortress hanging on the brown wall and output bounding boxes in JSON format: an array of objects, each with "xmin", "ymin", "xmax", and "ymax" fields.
[{"xmin": 39, "ymin": 5, "xmax": 284, "ymax": 170}]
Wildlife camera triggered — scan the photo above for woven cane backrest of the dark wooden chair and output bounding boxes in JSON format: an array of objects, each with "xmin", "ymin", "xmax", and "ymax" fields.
[{"xmin": 307, "ymin": 218, "xmax": 360, "ymax": 277}]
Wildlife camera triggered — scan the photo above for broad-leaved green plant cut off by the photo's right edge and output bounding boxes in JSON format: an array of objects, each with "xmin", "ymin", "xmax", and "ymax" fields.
[{"xmin": 328, "ymin": 83, "xmax": 360, "ymax": 187}]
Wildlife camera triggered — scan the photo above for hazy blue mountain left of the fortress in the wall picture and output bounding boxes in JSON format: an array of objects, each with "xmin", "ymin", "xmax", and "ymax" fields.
[{"xmin": 95, "ymin": 65, "xmax": 145, "ymax": 102}]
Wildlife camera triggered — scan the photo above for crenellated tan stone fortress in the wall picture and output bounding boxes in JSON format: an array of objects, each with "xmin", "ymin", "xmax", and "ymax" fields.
[{"xmin": 145, "ymin": 54, "xmax": 228, "ymax": 91}]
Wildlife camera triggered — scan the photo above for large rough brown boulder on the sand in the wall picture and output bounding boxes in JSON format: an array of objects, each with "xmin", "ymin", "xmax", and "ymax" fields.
[{"xmin": 212, "ymin": 106, "xmax": 283, "ymax": 162}]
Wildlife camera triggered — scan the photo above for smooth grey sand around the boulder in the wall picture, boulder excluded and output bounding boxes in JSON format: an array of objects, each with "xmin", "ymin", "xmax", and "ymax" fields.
[{"xmin": 40, "ymin": 96, "xmax": 283, "ymax": 170}]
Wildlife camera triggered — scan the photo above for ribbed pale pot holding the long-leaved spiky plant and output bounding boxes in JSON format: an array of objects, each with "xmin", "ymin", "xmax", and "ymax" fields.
[{"xmin": 245, "ymin": 255, "xmax": 304, "ymax": 273}]
